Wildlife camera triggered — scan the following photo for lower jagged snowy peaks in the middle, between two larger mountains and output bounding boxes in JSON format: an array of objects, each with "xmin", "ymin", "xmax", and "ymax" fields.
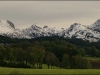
[{"xmin": 22, "ymin": 24, "xmax": 58, "ymax": 38}]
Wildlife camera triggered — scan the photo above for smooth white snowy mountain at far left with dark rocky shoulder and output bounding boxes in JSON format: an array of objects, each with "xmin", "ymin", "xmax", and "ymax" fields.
[{"xmin": 0, "ymin": 20, "xmax": 30, "ymax": 38}]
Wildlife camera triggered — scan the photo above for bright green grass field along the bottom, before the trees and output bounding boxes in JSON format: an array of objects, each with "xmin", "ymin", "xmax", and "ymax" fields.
[{"xmin": 0, "ymin": 67, "xmax": 100, "ymax": 75}]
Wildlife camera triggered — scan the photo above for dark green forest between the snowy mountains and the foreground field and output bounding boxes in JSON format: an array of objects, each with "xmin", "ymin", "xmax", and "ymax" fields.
[{"xmin": 0, "ymin": 36, "xmax": 100, "ymax": 69}]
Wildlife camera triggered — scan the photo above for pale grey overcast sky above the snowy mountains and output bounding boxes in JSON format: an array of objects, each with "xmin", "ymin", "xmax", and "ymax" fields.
[{"xmin": 0, "ymin": 1, "xmax": 100, "ymax": 29}]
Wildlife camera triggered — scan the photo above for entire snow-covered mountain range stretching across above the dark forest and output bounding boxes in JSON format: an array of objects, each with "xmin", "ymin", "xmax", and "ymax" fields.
[{"xmin": 0, "ymin": 19, "xmax": 100, "ymax": 42}]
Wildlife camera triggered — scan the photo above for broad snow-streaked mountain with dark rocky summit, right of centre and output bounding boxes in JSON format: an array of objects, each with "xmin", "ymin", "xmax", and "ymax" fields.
[{"xmin": 63, "ymin": 23, "xmax": 100, "ymax": 42}]
